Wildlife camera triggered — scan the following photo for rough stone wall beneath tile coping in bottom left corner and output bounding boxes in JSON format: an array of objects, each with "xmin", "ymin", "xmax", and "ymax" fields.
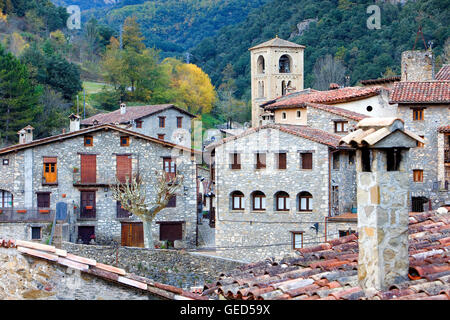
[{"xmin": 0, "ymin": 248, "xmax": 154, "ymax": 300}]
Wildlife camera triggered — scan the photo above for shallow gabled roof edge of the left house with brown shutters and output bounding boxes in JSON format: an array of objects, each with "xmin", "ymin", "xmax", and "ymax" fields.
[{"xmin": 0, "ymin": 124, "xmax": 199, "ymax": 154}]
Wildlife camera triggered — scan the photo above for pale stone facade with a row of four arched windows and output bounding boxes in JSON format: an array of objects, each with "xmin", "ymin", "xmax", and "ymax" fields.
[{"xmin": 211, "ymin": 129, "xmax": 356, "ymax": 261}]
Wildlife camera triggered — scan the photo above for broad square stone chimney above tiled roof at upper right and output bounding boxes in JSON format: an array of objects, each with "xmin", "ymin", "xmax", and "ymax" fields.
[{"xmin": 401, "ymin": 50, "xmax": 433, "ymax": 81}]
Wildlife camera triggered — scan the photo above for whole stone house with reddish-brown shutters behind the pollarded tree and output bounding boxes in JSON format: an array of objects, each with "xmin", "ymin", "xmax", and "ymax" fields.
[{"xmin": 0, "ymin": 115, "xmax": 197, "ymax": 247}]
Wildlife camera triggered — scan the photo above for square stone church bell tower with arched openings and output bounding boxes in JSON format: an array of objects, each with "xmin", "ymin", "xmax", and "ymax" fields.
[{"xmin": 249, "ymin": 36, "xmax": 305, "ymax": 127}]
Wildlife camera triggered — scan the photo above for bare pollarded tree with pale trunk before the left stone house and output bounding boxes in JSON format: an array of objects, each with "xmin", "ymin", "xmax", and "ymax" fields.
[{"xmin": 111, "ymin": 171, "xmax": 184, "ymax": 248}]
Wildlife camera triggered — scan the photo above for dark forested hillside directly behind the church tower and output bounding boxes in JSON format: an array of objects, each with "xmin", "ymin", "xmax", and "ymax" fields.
[{"xmin": 192, "ymin": 0, "xmax": 450, "ymax": 99}]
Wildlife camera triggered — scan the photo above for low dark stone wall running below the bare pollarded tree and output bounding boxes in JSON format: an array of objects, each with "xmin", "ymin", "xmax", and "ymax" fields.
[{"xmin": 62, "ymin": 242, "xmax": 243, "ymax": 288}]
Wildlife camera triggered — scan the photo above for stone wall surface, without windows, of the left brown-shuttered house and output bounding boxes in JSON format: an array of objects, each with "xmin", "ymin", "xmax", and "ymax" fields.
[{"xmin": 0, "ymin": 126, "xmax": 197, "ymax": 247}]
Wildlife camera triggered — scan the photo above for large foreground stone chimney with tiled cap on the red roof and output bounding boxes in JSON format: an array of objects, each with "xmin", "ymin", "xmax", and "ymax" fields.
[{"xmin": 340, "ymin": 118, "xmax": 423, "ymax": 292}]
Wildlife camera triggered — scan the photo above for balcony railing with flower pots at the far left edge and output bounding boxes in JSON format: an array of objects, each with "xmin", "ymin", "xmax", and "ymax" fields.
[{"xmin": 0, "ymin": 208, "xmax": 55, "ymax": 222}]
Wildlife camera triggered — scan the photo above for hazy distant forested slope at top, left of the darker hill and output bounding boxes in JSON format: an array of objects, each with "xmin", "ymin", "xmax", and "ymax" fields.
[{"xmin": 80, "ymin": 0, "xmax": 268, "ymax": 58}]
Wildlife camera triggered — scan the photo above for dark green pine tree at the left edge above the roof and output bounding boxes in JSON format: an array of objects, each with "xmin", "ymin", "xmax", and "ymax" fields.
[{"xmin": 0, "ymin": 46, "xmax": 40, "ymax": 145}]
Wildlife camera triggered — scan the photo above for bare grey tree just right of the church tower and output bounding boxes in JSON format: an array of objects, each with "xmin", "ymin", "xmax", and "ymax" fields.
[{"xmin": 313, "ymin": 54, "xmax": 347, "ymax": 90}]
